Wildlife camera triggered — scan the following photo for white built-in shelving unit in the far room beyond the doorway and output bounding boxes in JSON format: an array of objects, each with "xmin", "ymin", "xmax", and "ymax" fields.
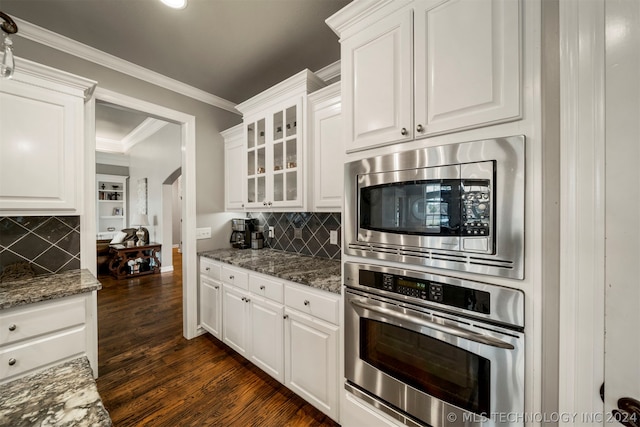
[{"xmin": 96, "ymin": 174, "xmax": 127, "ymax": 239}]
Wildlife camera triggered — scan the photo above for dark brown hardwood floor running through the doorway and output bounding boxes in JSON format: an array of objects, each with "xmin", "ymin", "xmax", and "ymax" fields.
[{"xmin": 97, "ymin": 252, "xmax": 337, "ymax": 427}]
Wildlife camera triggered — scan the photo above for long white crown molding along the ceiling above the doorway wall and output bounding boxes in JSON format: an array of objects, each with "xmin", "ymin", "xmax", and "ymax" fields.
[{"xmin": 14, "ymin": 18, "xmax": 239, "ymax": 114}]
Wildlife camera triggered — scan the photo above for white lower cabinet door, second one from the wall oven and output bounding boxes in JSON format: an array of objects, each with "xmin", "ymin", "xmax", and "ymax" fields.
[{"xmin": 249, "ymin": 296, "xmax": 284, "ymax": 382}]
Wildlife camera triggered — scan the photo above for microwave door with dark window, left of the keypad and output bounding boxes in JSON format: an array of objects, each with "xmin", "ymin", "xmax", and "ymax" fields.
[{"xmin": 358, "ymin": 165, "xmax": 462, "ymax": 250}]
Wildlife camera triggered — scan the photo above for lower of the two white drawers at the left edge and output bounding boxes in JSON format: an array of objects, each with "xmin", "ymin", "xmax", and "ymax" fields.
[{"xmin": 0, "ymin": 325, "xmax": 86, "ymax": 381}]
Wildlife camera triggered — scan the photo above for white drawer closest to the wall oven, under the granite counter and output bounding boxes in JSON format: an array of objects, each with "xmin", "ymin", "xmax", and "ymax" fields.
[{"xmin": 284, "ymin": 284, "xmax": 339, "ymax": 325}]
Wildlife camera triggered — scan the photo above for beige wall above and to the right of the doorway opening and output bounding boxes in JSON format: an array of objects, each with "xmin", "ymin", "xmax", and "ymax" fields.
[{"xmin": 14, "ymin": 37, "xmax": 242, "ymax": 251}]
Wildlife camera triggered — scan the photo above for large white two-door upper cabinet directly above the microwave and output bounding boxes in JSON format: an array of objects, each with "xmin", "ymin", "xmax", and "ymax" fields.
[{"xmin": 327, "ymin": 0, "xmax": 521, "ymax": 151}]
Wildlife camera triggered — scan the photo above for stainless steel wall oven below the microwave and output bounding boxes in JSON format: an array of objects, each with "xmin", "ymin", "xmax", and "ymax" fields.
[{"xmin": 344, "ymin": 262, "xmax": 524, "ymax": 427}]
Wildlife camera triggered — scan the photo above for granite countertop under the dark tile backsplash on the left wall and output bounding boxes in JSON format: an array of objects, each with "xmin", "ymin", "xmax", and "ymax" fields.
[{"xmin": 0, "ymin": 269, "xmax": 102, "ymax": 310}]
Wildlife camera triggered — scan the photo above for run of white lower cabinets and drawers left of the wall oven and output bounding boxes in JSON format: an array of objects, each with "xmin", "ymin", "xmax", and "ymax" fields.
[{"xmin": 200, "ymin": 258, "xmax": 340, "ymax": 421}]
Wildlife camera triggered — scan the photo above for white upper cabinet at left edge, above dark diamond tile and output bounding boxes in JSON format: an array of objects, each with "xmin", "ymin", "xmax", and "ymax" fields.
[{"xmin": 0, "ymin": 60, "xmax": 95, "ymax": 215}]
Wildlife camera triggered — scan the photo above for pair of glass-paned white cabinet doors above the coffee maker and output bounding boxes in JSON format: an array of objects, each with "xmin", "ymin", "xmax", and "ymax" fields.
[{"xmin": 246, "ymin": 99, "xmax": 303, "ymax": 208}]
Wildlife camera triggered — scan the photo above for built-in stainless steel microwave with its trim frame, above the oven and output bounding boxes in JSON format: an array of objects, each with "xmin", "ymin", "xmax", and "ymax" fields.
[{"xmin": 345, "ymin": 135, "xmax": 525, "ymax": 279}]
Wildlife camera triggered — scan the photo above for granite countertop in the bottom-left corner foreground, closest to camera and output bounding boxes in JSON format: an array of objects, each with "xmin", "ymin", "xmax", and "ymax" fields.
[{"xmin": 0, "ymin": 357, "xmax": 112, "ymax": 427}]
